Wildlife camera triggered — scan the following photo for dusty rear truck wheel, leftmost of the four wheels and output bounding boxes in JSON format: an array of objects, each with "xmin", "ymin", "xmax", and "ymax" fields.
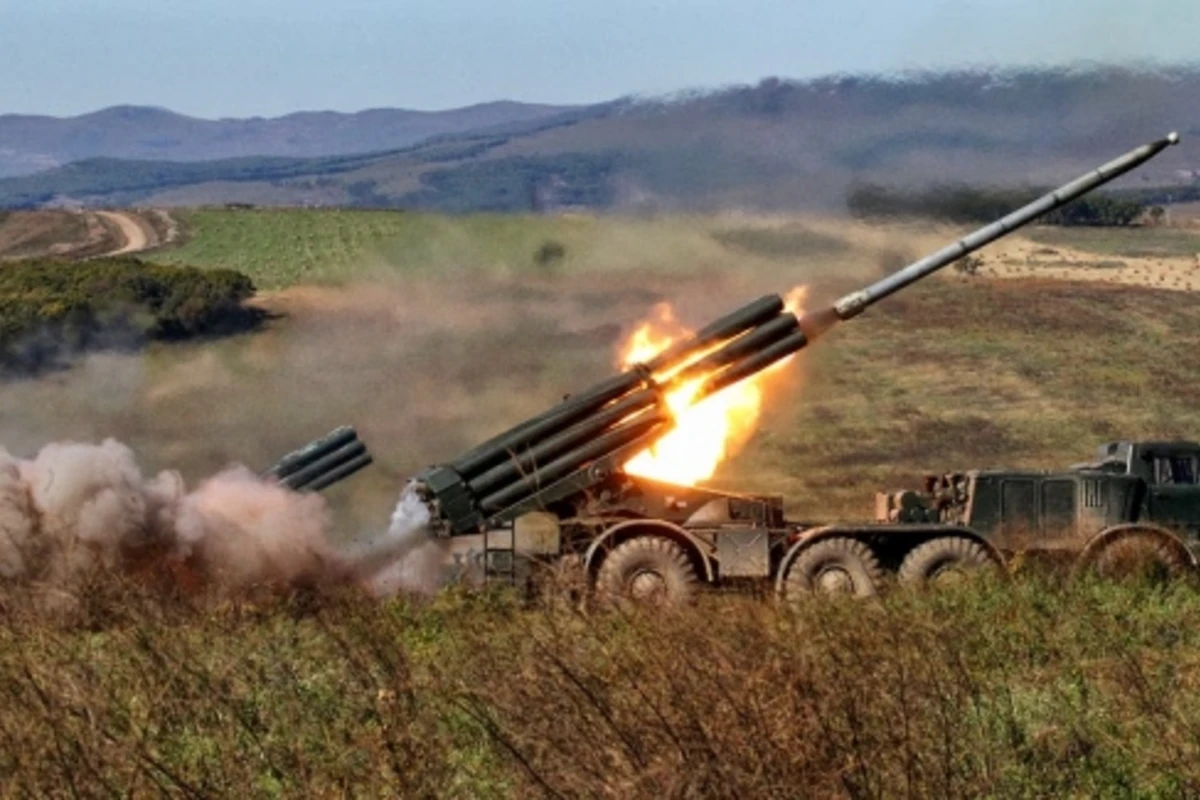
[{"xmin": 595, "ymin": 536, "xmax": 700, "ymax": 607}]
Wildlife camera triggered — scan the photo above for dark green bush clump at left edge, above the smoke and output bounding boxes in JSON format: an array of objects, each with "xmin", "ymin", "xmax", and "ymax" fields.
[{"xmin": 0, "ymin": 258, "xmax": 258, "ymax": 372}]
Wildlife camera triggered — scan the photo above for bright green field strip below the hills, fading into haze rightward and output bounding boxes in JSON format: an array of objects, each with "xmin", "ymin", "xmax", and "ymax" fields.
[{"xmin": 166, "ymin": 209, "xmax": 806, "ymax": 289}]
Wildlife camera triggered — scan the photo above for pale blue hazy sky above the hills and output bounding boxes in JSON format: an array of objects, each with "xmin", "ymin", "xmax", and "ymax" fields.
[{"xmin": 0, "ymin": 0, "xmax": 1200, "ymax": 116}]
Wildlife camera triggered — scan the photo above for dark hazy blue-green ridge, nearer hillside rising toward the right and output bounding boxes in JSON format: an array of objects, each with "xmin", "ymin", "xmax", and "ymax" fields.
[{"xmin": 0, "ymin": 68, "xmax": 1200, "ymax": 212}]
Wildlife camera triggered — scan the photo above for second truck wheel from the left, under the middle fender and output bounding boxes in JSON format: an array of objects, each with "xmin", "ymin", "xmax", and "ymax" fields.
[{"xmin": 784, "ymin": 536, "xmax": 883, "ymax": 600}]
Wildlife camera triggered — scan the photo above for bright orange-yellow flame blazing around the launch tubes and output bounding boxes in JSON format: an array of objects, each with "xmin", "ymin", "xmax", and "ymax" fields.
[{"xmin": 620, "ymin": 287, "xmax": 805, "ymax": 486}]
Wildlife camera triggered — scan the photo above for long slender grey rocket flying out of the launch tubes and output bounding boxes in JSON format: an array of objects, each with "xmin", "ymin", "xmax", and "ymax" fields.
[{"xmin": 834, "ymin": 133, "xmax": 1180, "ymax": 319}]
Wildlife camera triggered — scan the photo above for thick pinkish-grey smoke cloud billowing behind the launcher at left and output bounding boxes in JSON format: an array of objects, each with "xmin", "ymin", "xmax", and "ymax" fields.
[{"xmin": 0, "ymin": 439, "xmax": 438, "ymax": 606}]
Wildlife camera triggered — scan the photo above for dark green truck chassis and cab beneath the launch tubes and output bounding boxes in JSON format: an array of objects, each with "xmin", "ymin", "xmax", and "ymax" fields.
[{"xmin": 441, "ymin": 441, "xmax": 1200, "ymax": 604}]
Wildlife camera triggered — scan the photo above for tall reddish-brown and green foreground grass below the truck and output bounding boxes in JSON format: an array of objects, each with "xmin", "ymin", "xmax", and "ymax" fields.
[{"xmin": 7, "ymin": 577, "xmax": 1200, "ymax": 799}]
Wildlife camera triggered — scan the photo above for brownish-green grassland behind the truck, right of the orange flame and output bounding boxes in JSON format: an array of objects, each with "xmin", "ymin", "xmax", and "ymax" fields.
[{"xmin": 721, "ymin": 278, "xmax": 1200, "ymax": 518}]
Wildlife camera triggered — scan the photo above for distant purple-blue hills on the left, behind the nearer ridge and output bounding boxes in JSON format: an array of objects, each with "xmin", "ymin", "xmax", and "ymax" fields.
[{"xmin": 0, "ymin": 101, "xmax": 569, "ymax": 178}]
